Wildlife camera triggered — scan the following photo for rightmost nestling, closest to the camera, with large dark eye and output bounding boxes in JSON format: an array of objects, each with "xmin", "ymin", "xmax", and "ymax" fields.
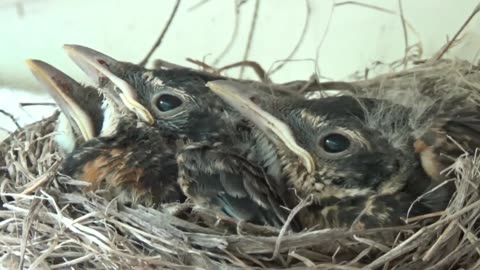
[{"xmin": 207, "ymin": 81, "xmax": 480, "ymax": 229}]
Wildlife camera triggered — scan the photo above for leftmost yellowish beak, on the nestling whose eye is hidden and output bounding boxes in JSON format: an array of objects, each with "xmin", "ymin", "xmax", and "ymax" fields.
[{"xmin": 26, "ymin": 59, "xmax": 95, "ymax": 141}]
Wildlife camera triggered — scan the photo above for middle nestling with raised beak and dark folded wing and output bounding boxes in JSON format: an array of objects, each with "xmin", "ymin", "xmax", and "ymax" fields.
[{"xmin": 60, "ymin": 45, "xmax": 296, "ymax": 225}]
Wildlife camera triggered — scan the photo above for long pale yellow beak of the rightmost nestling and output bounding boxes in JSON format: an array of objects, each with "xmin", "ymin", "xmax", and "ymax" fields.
[{"xmin": 207, "ymin": 80, "xmax": 315, "ymax": 173}]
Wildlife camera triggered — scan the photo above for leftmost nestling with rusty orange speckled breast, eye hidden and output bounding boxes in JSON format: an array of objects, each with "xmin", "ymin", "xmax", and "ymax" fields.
[{"xmin": 28, "ymin": 60, "xmax": 184, "ymax": 206}]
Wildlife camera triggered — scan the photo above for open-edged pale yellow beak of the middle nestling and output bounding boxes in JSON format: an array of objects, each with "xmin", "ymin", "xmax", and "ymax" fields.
[{"xmin": 63, "ymin": 44, "xmax": 154, "ymax": 125}]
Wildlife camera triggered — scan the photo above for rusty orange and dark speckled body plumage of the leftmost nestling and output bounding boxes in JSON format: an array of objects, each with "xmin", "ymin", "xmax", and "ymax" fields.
[{"xmin": 61, "ymin": 119, "xmax": 184, "ymax": 206}]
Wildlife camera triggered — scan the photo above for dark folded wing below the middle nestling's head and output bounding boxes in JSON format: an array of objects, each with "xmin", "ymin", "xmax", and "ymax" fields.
[{"xmin": 177, "ymin": 144, "xmax": 285, "ymax": 227}]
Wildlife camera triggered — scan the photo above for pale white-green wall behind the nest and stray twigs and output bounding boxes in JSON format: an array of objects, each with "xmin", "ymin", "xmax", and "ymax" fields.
[{"xmin": 0, "ymin": 0, "xmax": 480, "ymax": 139}]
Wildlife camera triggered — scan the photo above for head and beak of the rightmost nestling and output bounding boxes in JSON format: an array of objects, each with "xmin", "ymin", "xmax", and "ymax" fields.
[{"xmin": 207, "ymin": 81, "xmax": 418, "ymax": 200}]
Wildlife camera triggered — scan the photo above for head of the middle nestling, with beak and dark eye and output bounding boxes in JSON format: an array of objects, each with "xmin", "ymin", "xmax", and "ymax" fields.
[{"xmin": 64, "ymin": 45, "xmax": 278, "ymax": 141}]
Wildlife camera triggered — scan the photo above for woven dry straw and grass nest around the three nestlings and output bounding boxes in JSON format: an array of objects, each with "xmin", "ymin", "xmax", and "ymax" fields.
[{"xmin": 0, "ymin": 61, "xmax": 480, "ymax": 269}]
